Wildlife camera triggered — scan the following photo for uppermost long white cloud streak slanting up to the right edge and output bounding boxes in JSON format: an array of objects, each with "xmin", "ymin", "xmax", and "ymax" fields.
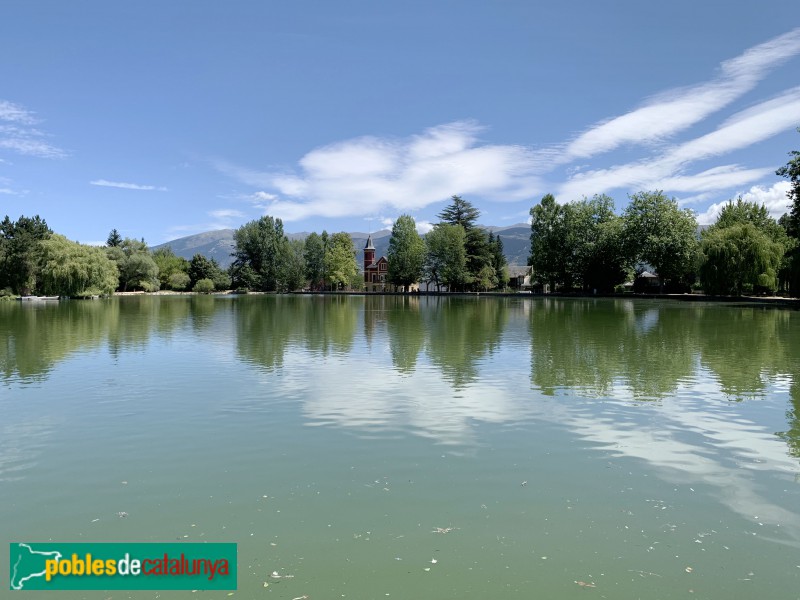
[{"xmin": 562, "ymin": 27, "xmax": 800, "ymax": 162}]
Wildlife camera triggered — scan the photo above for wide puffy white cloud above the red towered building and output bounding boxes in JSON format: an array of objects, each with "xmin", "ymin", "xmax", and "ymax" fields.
[{"xmin": 216, "ymin": 121, "xmax": 540, "ymax": 221}]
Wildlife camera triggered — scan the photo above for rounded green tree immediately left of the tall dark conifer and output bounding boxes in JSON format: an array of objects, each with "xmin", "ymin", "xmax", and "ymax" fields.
[{"xmin": 424, "ymin": 224, "xmax": 469, "ymax": 291}]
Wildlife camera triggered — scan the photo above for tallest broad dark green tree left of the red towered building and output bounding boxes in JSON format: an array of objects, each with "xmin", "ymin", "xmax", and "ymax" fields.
[{"xmin": 231, "ymin": 216, "xmax": 289, "ymax": 292}]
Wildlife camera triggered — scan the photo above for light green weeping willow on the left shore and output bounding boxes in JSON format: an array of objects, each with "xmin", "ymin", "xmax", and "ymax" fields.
[{"xmin": 40, "ymin": 234, "xmax": 119, "ymax": 297}]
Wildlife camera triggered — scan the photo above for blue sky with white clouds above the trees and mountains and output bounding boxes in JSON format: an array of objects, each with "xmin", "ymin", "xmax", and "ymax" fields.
[{"xmin": 0, "ymin": 0, "xmax": 800, "ymax": 244}]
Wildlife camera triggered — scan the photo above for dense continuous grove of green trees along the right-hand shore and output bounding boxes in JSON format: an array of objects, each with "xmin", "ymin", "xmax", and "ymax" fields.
[{"xmin": 528, "ymin": 130, "xmax": 800, "ymax": 296}]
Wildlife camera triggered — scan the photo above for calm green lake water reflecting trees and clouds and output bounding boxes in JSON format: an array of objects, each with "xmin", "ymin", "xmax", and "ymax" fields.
[{"xmin": 0, "ymin": 296, "xmax": 800, "ymax": 600}]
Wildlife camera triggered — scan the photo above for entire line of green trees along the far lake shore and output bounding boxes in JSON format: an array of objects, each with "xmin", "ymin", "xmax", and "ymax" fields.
[{"xmin": 0, "ymin": 130, "xmax": 800, "ymax": 297}]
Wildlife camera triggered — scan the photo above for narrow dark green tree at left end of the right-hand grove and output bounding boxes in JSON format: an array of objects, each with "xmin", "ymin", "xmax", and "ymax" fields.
[{"xmin": 528, "ymin": 194, "xmax": 567, "ymax": 291}]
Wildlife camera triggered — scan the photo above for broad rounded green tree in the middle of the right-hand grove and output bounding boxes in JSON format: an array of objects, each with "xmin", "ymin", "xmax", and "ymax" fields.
[{"xmin": 622, "ymin": 191, "xmax": 699, "ymax": 291}]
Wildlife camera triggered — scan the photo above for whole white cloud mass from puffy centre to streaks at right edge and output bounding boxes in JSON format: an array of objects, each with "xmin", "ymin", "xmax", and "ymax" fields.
[{"xmin": 214, "ymin": 27, "xmax": 800, "ymax": 221}]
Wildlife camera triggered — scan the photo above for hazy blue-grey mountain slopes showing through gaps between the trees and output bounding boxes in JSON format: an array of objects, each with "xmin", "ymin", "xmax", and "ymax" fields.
[{"xmin": 151, "ymin": 224, "xmax": 531, "ymax": 268}]
